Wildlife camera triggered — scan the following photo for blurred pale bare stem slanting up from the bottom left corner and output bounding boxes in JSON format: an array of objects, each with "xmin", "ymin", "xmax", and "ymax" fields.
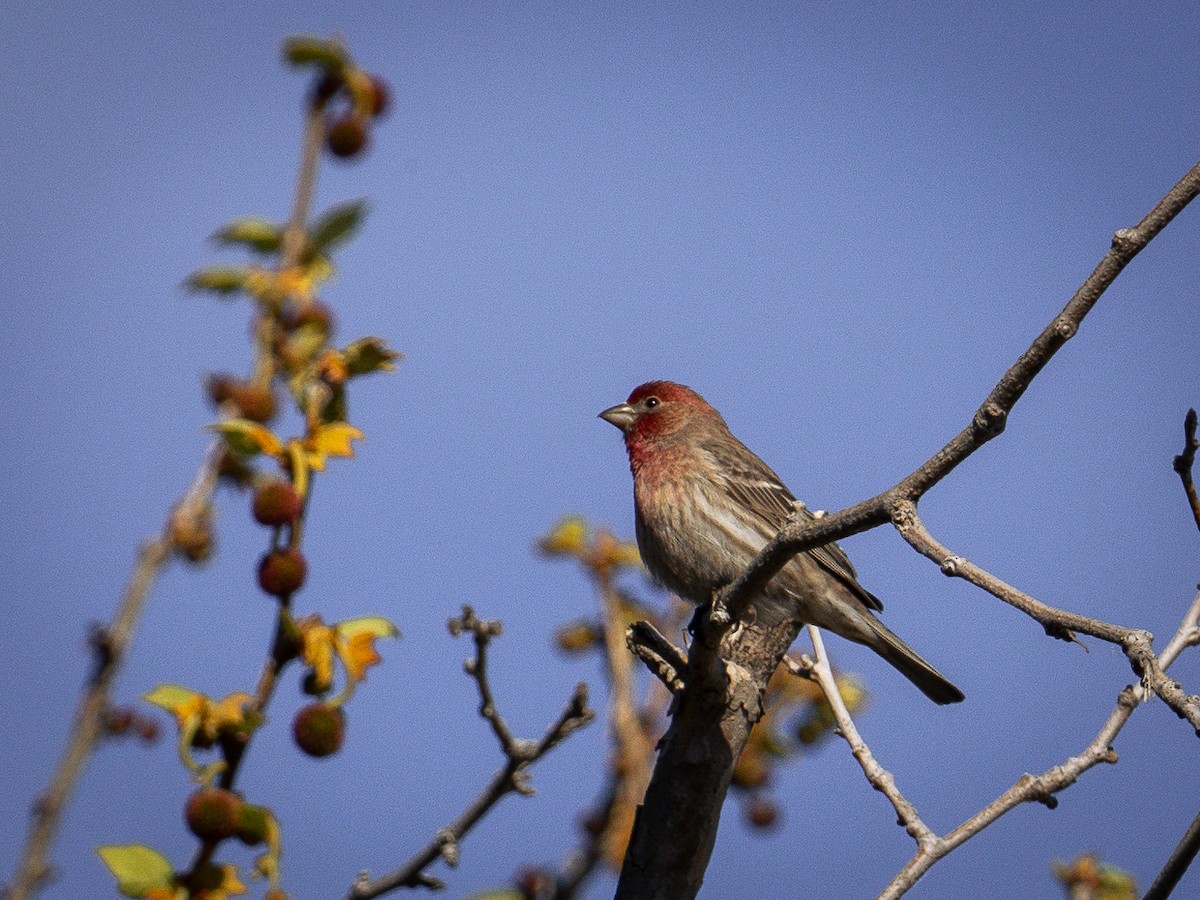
[{"xmin": 4, "ymin": 442, "xmax": 222, "ymax": 900}]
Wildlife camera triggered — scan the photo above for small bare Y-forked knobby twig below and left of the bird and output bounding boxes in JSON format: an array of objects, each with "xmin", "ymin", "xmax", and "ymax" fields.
[{"xmin": 347, "ymin": 605, "xmax": 595, "ymax": 900}]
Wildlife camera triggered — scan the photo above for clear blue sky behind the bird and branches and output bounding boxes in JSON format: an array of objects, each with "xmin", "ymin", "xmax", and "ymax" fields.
[{"xmin": 0, "ymin": 2, "xmax": 1200, "ymax": 898}]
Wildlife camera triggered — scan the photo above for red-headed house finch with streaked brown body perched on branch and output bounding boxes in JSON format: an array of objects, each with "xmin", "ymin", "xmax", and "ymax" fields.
[{"xmin": 600, "ymin": 382, "xmax": 962, "ymax": 703}]
